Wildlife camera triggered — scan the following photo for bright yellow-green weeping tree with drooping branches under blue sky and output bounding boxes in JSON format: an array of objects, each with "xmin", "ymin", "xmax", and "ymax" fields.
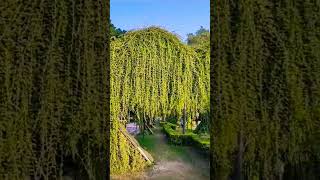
[{"xmin": 110, "ymin": 27, "xmax": 209, "ymax": 173}]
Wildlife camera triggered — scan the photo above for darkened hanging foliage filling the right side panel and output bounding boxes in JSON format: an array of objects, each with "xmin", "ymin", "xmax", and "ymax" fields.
[{"xmin": 211, "ymin": 0, "xmax": 320, "ymax": 180}]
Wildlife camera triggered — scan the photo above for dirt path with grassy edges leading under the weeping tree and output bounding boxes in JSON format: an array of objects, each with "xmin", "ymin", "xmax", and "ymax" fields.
[{"xmin": 112, "ymin": 128, "xmax": 210, "ymax": 180}]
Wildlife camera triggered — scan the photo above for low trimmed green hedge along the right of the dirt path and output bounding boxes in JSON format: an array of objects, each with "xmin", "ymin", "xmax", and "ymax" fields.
[{"xmin": 162, "ymin": 123, "xmax": 210, "ymax": 151}]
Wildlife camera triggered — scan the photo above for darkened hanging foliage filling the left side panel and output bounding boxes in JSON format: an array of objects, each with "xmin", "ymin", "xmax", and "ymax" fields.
[{"xmin": 0, "ymin": 0, "xmax": 109, "ymax": 179}]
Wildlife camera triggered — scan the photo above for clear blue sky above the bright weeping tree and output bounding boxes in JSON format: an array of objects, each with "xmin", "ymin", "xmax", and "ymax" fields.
[{"xmin": 110, "ymin": 0, "xmax": 210, "ymax": 40}]
